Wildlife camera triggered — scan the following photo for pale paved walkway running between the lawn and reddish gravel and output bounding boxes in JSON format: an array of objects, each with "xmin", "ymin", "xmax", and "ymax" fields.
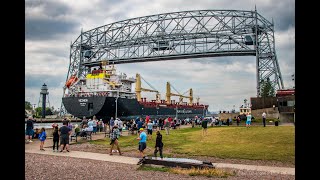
[{"xmin": 25, "ymin": 129, "xmax": 295, "ymax": 175}]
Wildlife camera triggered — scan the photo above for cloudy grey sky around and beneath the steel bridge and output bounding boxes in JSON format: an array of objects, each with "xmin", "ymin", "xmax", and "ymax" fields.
[{"xmin": 25, "ymin": 0, "xmax": 295, "ymax": 112}]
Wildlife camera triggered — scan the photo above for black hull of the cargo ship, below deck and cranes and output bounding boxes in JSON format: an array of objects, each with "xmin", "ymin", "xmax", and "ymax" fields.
[{"xmin": 62, "ymin": 96, "xmax": 206, "ymax": 120}]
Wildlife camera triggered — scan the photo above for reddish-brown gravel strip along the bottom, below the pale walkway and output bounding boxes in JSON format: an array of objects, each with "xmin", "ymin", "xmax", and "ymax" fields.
[{"xmin": 25, "ymin": 153, "xmax": 295, "ymax": 180}]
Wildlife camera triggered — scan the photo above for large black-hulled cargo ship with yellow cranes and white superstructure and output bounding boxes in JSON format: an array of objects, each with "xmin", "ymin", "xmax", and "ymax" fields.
[{"xmin": 62, "ymin": 64, "xmax": 208, "ymax": 120}]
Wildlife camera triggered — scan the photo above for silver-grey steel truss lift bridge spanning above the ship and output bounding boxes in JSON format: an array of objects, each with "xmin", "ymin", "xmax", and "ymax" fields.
[{"xmin": 59, "ymin": 10, "xmax": 284, "ymax": 116}]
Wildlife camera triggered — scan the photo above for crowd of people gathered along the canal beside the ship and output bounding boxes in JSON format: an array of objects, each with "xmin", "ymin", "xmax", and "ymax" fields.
[{"xmin": 26, "ymin": 112, "xmax": 266, "ymax": 159}]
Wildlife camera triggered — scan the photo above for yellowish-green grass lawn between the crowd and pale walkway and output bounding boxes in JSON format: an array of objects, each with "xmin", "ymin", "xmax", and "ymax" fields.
[{"xmin": 92, "ymin": 126, "xmax": 295, "ymax": 164}]
